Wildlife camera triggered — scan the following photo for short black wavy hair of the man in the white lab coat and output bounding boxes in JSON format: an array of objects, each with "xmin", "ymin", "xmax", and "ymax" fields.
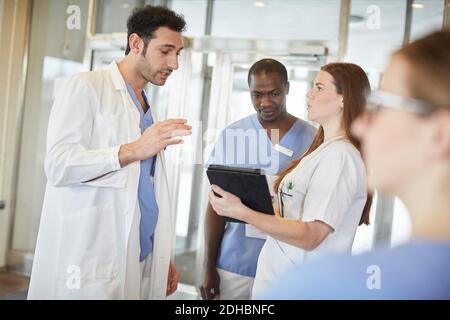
[{"xmin": 125, "ymin": 5, "xmax": 186, "ymax": 55}]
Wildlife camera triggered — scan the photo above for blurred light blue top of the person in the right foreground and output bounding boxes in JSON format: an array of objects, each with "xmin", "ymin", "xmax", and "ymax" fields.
[{"xmin": 254, "ymin": 239, "xmax": 450, "ymax": 300}]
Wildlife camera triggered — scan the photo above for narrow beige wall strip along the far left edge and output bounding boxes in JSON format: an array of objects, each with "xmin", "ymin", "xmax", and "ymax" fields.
[{"xmin": 0, "ymin": 0, "xmax": 31, "ymax": 267}]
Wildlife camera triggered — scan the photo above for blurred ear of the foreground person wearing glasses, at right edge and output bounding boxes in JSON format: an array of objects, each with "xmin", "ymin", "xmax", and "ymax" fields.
[{"xmin": 428, "ymin": 110, "xmax": 450, "ymax": 160}]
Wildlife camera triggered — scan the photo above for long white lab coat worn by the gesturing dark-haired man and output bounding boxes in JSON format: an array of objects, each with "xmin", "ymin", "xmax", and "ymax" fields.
[{"xmin": 28, "ymin": 62, "xmax": 172, "ymax": 299}]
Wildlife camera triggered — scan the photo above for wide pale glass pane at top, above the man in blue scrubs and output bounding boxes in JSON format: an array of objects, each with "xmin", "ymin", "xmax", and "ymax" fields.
[{"xmin": 212, "ymin": 0, "xmax": 340, "ymax": 41}]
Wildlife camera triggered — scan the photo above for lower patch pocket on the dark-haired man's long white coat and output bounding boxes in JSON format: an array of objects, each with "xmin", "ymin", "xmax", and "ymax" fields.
[{"xmin": 58, "ymin": 203, "xmax": 118, "ymax": 281}]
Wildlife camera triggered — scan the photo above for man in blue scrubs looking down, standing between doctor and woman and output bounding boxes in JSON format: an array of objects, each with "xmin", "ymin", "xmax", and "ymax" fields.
[{"xmin": 200, "ymin": 59, "xmax": 315, "ymax": 300}]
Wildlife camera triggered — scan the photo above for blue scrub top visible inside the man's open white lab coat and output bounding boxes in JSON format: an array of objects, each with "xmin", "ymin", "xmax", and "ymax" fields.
[{"xmin": 127, "ymin": 83, "xmax": 159, "ymax": 261}]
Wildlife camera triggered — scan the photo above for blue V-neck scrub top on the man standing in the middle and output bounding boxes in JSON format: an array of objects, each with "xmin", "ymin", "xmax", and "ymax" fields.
[{"xmin": 206, "ymin": 114, "xmax": 316, "ymax": 278}]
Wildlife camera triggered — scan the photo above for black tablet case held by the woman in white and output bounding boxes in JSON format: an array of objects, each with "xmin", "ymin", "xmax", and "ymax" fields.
[{"xmin": 206, "ymin": 165, "xmax": 275, "ymax": 223}]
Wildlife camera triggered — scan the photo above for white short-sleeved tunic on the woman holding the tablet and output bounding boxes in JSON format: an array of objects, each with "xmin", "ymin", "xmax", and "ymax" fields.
[{"xmin": 252, "ymin": 136, "xmax": 367, "ymax": 297}]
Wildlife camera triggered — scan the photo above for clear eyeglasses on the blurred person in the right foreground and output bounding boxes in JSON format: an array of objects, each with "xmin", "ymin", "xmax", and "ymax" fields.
[{"xmin": 366, "ymin": 90, "xmax": 435, "ymax": 115}]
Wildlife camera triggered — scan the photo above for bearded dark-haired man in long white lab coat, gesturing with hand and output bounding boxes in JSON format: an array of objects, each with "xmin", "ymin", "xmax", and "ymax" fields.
[{"xmin": 28, "ymin": 6, "xmax": 191, "ymax": 299}]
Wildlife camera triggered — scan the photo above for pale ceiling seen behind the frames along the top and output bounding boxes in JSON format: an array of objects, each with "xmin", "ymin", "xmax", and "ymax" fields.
[{"xmin": 97, "ymin": 0, "xmax": 444, "ymax": 70}]
